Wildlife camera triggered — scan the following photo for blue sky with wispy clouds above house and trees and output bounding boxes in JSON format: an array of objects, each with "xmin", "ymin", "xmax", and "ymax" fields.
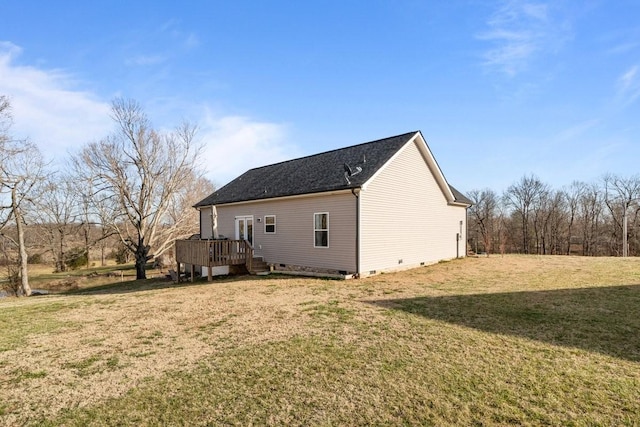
[{"xmin": 0, "ymin": 0, "xmax": 640, "ymax": 192}]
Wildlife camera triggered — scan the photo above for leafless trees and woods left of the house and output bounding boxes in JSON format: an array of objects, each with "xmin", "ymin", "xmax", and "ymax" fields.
[{"xmin": 0, "ymin": 95, "xmax": 214, "ymax": 296}]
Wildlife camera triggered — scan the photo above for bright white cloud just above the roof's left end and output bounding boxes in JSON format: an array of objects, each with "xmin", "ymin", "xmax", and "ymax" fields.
[{"xmin": 200, "ymin": 111, "xmax": 300, "ymax": 187}]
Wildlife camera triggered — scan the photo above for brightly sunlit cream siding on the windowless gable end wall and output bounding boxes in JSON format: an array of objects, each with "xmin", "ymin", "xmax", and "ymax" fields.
[{"xmin": 360, "ymin": 142, "xmax": 466, "ymax": 275}]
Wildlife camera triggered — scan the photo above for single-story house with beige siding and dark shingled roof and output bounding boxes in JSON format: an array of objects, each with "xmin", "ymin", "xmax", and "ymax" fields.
[{"xmin": 184, "ymin": 131, "xmax": 471, "ymax": 277}]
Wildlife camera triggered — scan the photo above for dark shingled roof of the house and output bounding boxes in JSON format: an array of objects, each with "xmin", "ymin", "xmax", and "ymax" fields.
[{"xmin": 195, "ymin": 132, "xmax": 471, "ymax": 207}]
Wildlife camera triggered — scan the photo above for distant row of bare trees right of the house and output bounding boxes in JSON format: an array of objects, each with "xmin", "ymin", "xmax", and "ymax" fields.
[{"xmin": 468, "ymin": 174, "xmax": 640, "ymax": 256}]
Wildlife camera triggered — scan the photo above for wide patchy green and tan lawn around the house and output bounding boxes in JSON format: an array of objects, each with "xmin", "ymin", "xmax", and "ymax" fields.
[{"xmin": 0, "ymin": 256, "xmax": 640, "ymax": 426}]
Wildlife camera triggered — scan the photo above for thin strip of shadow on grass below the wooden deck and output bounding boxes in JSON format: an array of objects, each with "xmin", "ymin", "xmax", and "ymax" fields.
[{"xmin": 60, "ymin": 275, "xmax": 298, "ymax": 295}]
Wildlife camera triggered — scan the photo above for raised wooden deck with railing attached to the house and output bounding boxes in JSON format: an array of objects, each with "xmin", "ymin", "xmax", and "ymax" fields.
[{"xmin": 175, "ymin": 240, "xmax": 253, "ymax": 281}]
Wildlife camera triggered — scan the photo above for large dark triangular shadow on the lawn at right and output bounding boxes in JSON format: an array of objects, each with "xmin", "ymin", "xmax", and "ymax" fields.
[{"xmin": 370, "ymin": 285, "xmax": 640, "ymax": 362}]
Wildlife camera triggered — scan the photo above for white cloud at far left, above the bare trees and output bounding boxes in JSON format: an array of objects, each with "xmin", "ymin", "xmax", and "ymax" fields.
[{"xmin": 0, "ymin": 42, "xmax": 112, "ymax": 164}]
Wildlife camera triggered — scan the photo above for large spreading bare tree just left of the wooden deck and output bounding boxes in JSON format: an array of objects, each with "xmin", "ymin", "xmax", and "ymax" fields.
[{"xmin": 75, "ymin": 99, "xmax": 205, "ymax": 279}]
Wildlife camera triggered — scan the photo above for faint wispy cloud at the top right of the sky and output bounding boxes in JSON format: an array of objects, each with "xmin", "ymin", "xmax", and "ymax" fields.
[{"xmin": 477, "ymin": 0, "xmax": 566, "ymax": 77}]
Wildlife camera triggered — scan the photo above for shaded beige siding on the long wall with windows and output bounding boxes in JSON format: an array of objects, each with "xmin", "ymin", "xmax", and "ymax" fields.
[{"xmin": 217, "ymin": 192, "xmax": 356, "ymax": 273}]
